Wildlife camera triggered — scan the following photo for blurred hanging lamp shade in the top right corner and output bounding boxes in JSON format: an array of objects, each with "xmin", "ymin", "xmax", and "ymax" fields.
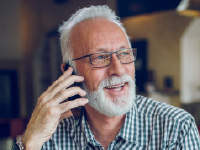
[{"xmin": 176, "ymin": 0, "xmax": 200, "ymax": 17}]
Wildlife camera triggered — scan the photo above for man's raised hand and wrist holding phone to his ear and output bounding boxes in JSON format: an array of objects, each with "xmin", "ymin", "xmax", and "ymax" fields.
[{"xmin": 22, "ymin": 67, "xmax": 88, "ymax": 150}]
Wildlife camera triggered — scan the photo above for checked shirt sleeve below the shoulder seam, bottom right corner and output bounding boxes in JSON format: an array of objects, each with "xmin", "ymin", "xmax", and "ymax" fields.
[{"xmin": 176, "ymin": 118, "xmax": 200, "ymax": 150}]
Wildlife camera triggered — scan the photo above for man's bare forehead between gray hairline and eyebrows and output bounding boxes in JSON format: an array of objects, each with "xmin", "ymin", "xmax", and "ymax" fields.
[{"xmin": 72, "ymin": 19, "xmax": 126, "ymax": 56}]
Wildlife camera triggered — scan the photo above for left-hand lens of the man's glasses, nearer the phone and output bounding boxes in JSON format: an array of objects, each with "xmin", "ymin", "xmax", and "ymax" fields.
[{"xmin": 90, "ymin": 53, "xmax": 111, "ymax": 68}]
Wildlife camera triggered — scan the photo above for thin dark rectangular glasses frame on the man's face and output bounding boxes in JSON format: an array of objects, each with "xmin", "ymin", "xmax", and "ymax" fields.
[{"xmin": 72, "ymin": 48, "xmax": 137, "ymax": 68}]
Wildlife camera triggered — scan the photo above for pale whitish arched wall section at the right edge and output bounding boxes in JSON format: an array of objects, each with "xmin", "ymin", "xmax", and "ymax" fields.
[{"xmin": 180, "ymin": 18, "xmax": 200, "ymax": 103}]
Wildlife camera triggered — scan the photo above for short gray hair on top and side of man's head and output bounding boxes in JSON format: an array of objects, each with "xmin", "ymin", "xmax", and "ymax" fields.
[{"xmin": 59, "ymin": 5, "xmax": 131, "ymax": 69}]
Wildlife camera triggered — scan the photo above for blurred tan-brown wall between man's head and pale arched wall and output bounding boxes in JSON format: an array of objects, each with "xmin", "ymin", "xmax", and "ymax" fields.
[{"xmin": 123, "ymin": 11, "xmax": 192, "ymax": 91}]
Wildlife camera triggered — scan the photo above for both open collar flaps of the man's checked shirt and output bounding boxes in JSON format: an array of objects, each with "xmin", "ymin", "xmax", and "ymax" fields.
[{"xmin": 71, "ymin": 100, "xmax": 139, "ymax": 147}]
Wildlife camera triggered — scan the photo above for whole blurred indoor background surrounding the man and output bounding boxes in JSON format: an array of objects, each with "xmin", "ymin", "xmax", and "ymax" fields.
[{"xmin": 0, "ymin": 0, "xmax": 200, "ymax": 149}]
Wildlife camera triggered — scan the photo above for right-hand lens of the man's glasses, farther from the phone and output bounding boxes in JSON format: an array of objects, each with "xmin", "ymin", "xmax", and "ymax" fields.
[{"xmin": 117, "ymin": 48, "xmax": 135, "ymax": 64}]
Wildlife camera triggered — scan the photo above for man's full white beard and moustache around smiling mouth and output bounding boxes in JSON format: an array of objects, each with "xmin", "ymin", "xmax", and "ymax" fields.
[{"xmin": 84, "ymin": 74, "xmax": 136, "ymax": 117}]
